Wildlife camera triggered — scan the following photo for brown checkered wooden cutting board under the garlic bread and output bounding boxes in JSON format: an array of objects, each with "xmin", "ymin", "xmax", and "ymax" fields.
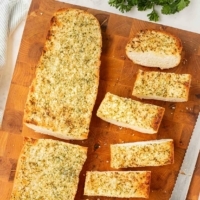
[{"xmin": 0, "ymin": 0, "xmax": 200, "ymax": 200}]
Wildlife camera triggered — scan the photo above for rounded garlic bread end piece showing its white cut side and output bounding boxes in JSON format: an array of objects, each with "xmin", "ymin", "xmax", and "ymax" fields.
[{"xmin": 126, "ymin": 30, "xmax": 183, "ymax": 69}]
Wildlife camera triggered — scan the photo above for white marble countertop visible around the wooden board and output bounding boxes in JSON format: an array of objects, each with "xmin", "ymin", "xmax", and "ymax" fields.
[{"xmin": 0, "ymin": 0, "xmax": 200, "ymax": 126}]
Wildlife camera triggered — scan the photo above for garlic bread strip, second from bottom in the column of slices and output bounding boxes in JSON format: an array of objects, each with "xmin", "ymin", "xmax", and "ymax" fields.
[{"xmin": 110, "ymin": 139, "xmax": 174, "ymax": 169}]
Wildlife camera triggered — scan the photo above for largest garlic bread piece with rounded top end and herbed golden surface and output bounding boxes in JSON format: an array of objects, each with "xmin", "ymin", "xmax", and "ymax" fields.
[{"xmin": 24, "ymin": 9, "xmax": 102, "ymax": 140}]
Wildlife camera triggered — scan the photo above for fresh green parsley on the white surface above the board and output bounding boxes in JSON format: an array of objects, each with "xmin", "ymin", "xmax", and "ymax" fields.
[{"xmin": 108, "ymin": 0, "xmax": 190, "ymax": 22}]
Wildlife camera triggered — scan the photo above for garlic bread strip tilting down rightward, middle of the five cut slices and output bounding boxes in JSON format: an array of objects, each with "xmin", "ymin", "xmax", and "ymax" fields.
[{"xmin": 97, "ymin": 92, "xmax": 165, "ymax": 134}]
